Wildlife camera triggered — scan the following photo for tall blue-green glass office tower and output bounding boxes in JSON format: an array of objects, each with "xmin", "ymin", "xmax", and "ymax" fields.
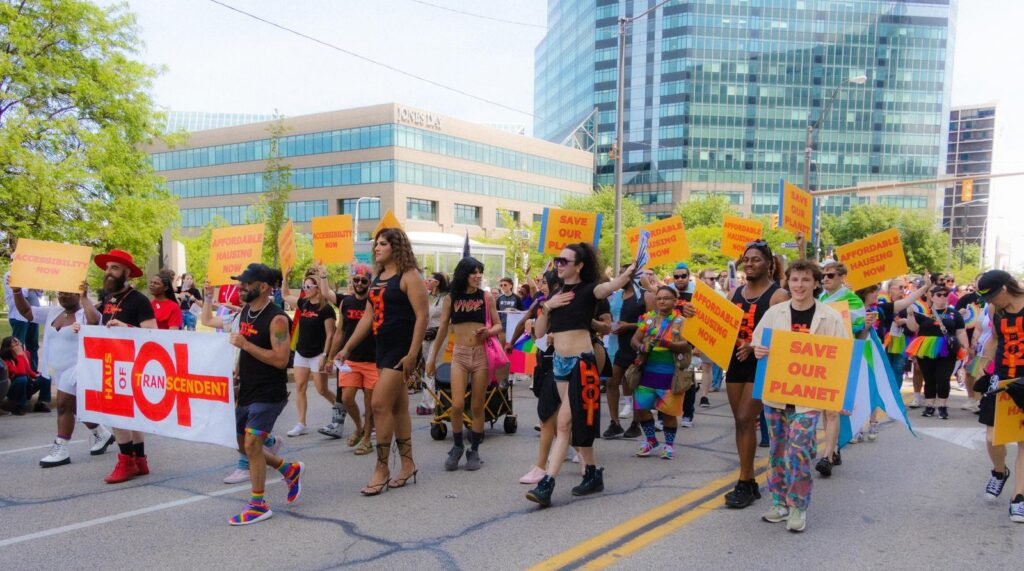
[{"xmin": 535, "ymin": 0, "xmax": 955, "ymax": 217}]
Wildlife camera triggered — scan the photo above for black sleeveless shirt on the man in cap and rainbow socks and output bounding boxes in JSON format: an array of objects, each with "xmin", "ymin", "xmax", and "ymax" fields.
[{"xmin": 239, "ymin": 303, "xmax": 288, "ymax": 406}]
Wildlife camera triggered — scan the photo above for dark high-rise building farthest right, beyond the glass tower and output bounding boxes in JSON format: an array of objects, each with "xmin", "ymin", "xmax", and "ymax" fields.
[{"xmin": 942, "ymin": 103, "xmax": 995, "ymax": 250}]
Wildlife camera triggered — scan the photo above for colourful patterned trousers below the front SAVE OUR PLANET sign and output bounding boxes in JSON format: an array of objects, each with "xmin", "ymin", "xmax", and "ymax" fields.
[{"xmin": 765, "ymin": 405, "xmax": 820, "ymax": 510}]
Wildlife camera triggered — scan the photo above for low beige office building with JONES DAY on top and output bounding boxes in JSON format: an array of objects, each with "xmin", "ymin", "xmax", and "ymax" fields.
[{"xmin": 148, "ymin": 103, "xmax": 594, "ymax": 240}]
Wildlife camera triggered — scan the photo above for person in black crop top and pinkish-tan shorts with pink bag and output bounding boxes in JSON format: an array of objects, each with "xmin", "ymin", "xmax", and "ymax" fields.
[{"xmin": 427, "ymin": 257, "xmax": 502, "ymax": 471}]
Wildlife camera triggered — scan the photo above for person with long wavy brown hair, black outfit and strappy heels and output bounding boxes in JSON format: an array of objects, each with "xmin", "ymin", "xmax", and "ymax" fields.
[{"xmin": 338, "ymin": 228, "xmax": 429, "ymax": 495}]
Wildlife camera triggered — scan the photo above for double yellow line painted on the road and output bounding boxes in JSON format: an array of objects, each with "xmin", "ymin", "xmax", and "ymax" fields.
[{"xmin": 530, "ymin": 459, "xmax": 768, "ymax": 571}]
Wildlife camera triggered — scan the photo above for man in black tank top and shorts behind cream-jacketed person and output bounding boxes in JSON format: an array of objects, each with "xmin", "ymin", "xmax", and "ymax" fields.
[{"xmin": 725, "ymin": 240, "xmax": 790, "ymax": 509}]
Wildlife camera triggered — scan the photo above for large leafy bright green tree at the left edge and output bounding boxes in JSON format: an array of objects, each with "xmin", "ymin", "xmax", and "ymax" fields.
[{"xmin": 0, "ymin": 0, "xmax": 178, "ymax": 260}]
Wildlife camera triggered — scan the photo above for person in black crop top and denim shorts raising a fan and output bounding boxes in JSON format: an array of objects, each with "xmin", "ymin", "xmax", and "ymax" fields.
[{"xmin": 526, "ymin": 243, "xmax": 634, "ymax": 508}]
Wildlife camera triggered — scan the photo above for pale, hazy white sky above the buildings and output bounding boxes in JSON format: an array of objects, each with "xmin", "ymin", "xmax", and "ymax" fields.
[{"xmin": 105, "ymin": 0, "xmax": 1024, "ymax": 267}]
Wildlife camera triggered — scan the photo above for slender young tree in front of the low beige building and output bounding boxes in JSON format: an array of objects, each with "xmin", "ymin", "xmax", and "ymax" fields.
[{"xmin": 251, "ymin": 115, "xmax": 292, "ymax": 267}]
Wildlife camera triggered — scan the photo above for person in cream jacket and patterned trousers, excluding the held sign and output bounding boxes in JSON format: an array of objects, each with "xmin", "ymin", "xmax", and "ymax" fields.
[{"xmin": 751, "ymin": 260, "xmax": 850, "ymax": 532}]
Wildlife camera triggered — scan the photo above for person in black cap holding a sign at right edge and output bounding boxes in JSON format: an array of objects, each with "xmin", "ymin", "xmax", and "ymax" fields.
[{"xmin": 966, "ymin": 270, "xmax": 1024, "ymax": 523}]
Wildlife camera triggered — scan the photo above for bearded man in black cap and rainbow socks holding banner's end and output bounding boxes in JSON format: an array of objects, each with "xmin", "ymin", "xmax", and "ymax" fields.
[{"xmin": 203, "ymin": 264, "xmax": 305, "ymax": 525}]
